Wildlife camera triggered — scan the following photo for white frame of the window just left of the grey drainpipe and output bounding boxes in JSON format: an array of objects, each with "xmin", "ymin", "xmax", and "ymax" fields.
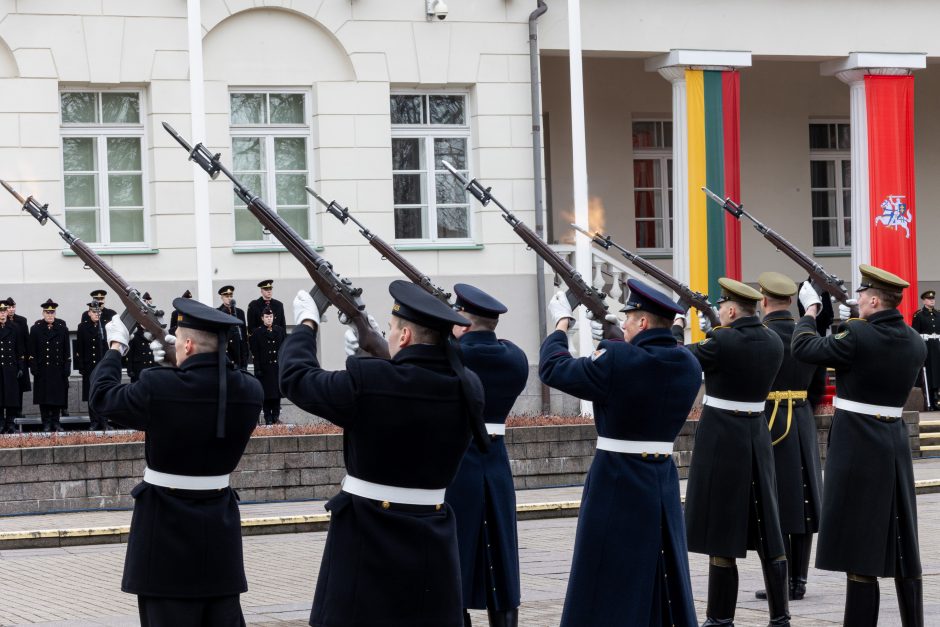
[{"xmin": 389, "ymin": 89, "xmax": 477, "ymax": 249}]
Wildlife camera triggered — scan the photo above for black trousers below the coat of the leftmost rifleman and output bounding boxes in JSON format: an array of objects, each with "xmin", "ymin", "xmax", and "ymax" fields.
[{"xmin": 137, "ymin": 594, "xmax": 245, "ymax": 627}]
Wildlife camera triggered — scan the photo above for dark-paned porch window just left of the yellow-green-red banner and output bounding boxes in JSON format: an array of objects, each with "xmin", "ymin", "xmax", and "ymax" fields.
[{"xmin": 633, "ymin": 120, "xmax": 672, "ymax": 252}]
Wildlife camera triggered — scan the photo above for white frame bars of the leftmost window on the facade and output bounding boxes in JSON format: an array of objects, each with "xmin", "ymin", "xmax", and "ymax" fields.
[{"xmin": 58, "ymin": 86, "xmax": 151, "ymax": 251}]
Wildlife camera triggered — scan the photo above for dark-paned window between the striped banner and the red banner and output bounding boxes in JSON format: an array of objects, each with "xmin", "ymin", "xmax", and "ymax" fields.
[{"xmin": 809, "ymin": 122, "xmax": 852, "ymax": 252}]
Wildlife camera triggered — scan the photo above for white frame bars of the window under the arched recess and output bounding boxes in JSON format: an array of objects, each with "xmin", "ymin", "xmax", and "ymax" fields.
[{"xmin": 227, "ymin": 86, "xmax": 319, "ymax": 245}]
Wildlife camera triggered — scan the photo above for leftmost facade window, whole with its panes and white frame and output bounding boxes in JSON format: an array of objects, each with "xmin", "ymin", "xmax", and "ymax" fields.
[{"xmin": 59, "ymin": 90, "xmax": 148, "ymax": 248}]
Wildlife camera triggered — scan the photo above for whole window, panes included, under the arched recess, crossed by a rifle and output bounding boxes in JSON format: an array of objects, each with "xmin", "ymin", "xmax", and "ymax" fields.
[{"xmin": 229, "ymin": 90, "xmax": 312, "ymax": 243}]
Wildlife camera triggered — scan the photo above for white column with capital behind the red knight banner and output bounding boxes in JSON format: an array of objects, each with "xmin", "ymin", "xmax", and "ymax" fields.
[{"xmin": 819, "ymin": 52, "xmax": 927, "ymax": 289}]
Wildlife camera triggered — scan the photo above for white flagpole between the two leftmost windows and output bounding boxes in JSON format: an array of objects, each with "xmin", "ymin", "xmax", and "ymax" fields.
[{"xmin": 186, "ymin": 0, "xmax": 214, "ymax": 305}]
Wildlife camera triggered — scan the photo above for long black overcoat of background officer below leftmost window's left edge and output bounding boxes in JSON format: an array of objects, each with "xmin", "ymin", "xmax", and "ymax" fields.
[{"xmin": 29, "ymin": 318, "xmax": 72, "ymax": 407}]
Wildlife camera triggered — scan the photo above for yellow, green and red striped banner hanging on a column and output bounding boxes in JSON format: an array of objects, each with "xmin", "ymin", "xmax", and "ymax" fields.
[{"xmin": 685, "ymin": 70, "xmax": 741, "ymax": 326}]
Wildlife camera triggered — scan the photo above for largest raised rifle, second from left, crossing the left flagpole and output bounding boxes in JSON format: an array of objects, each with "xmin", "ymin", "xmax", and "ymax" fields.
[{"xmin": 163, "ymin": 122, "xmax": 389, "ymax": 359}]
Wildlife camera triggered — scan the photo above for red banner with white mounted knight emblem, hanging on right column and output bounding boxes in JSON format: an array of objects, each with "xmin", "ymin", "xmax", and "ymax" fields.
[{"xmin": 865, "ymin": 76, "xmax": 918, "ymax": 320}]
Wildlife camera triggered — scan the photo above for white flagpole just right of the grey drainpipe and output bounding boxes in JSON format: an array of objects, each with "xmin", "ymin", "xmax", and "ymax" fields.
[{"xmin": 568, "ymin": 0, "xmax": 594, "ymax": 414}]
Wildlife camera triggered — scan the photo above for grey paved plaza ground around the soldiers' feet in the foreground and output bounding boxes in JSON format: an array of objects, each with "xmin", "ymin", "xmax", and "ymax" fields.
[{"xmin": 0, "ymin": 494, "xmax": 940, "ymax": 627}]
